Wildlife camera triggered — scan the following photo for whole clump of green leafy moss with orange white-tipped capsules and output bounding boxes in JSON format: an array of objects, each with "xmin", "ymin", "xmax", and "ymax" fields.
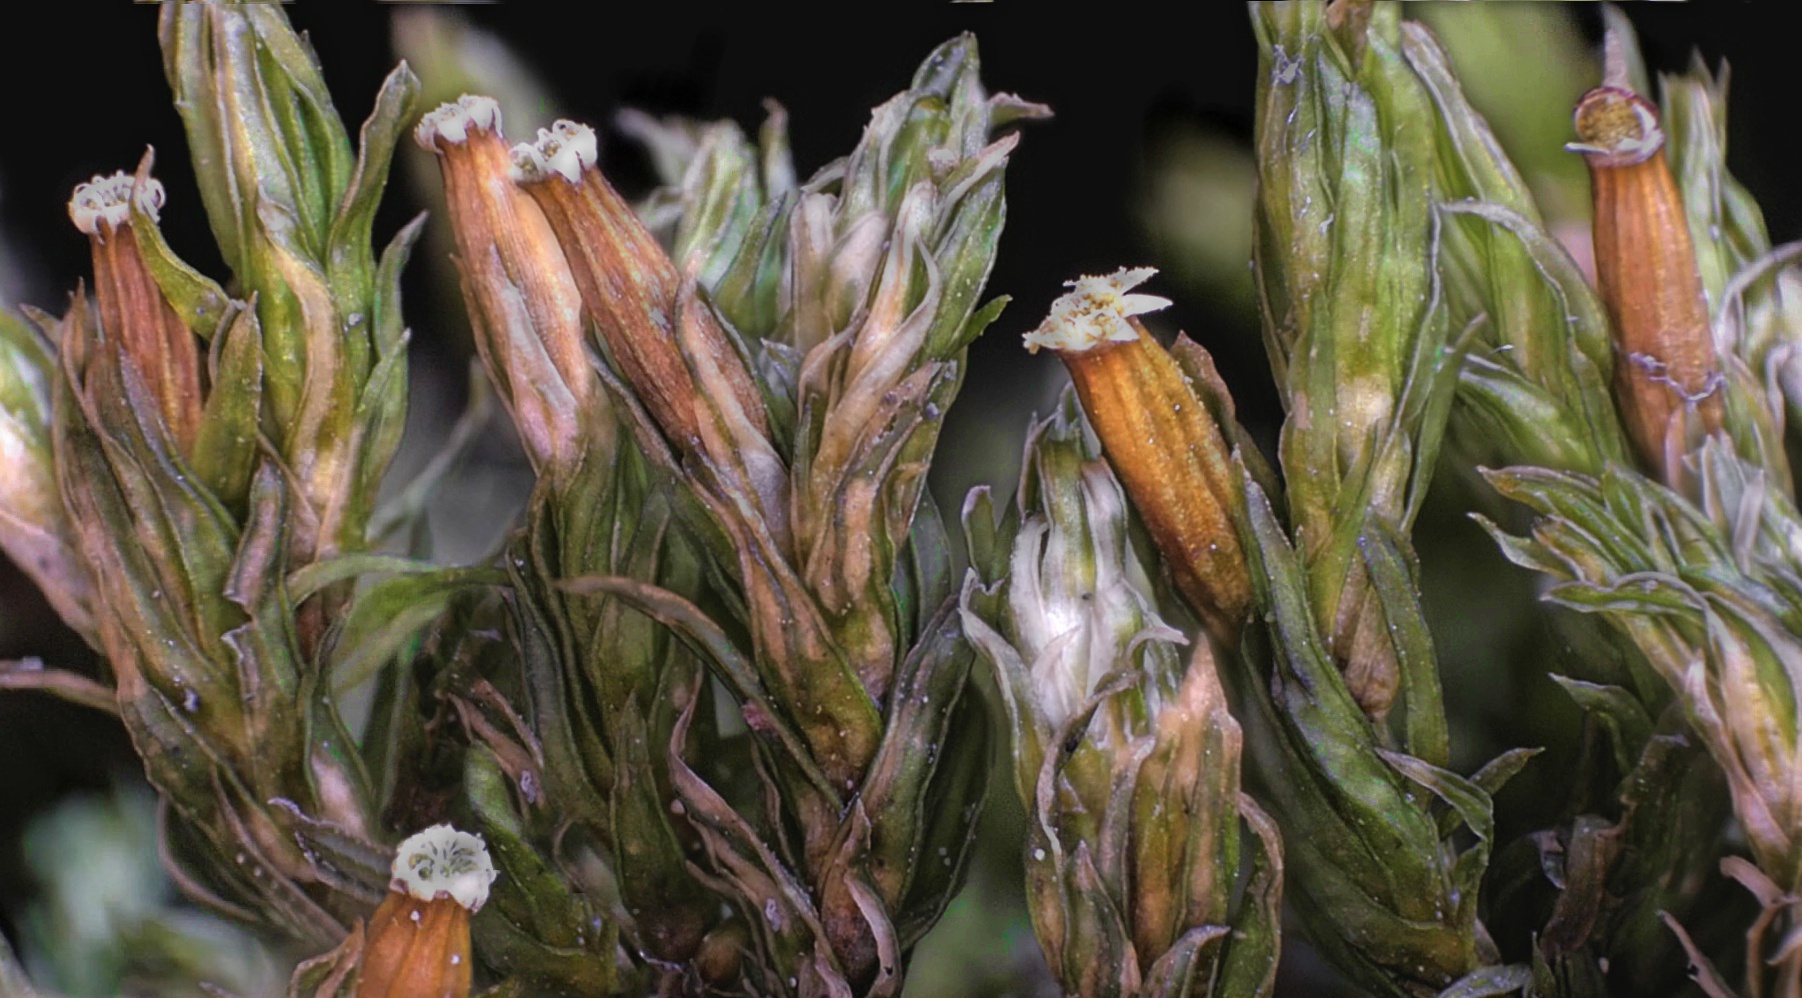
[{"xmin": 10, "ymin": 0, "xmax": 1802, "ymax": 998}]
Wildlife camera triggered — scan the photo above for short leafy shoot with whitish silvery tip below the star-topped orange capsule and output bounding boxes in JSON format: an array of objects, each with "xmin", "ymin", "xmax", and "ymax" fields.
[{"xmin": 962, "ymin": 393, "xmax": 1283, "ymax": 996}]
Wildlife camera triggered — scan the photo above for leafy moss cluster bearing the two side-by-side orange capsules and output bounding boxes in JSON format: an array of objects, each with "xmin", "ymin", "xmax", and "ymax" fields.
[{"xmin": 401, "ymin": 38, "xmax": 1042, "ymax": 994}]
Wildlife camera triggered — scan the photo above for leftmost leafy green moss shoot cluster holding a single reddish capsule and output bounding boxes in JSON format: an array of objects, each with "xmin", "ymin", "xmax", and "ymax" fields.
[{"xmin": 7, "ymin": 5, "xmax": 418, "ymax": 942}]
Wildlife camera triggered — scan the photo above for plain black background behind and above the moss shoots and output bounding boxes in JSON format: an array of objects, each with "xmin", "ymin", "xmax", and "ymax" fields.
[{"xmin": 0, "ymin": 0, "xmax": 1802, "ymax": 965}]
